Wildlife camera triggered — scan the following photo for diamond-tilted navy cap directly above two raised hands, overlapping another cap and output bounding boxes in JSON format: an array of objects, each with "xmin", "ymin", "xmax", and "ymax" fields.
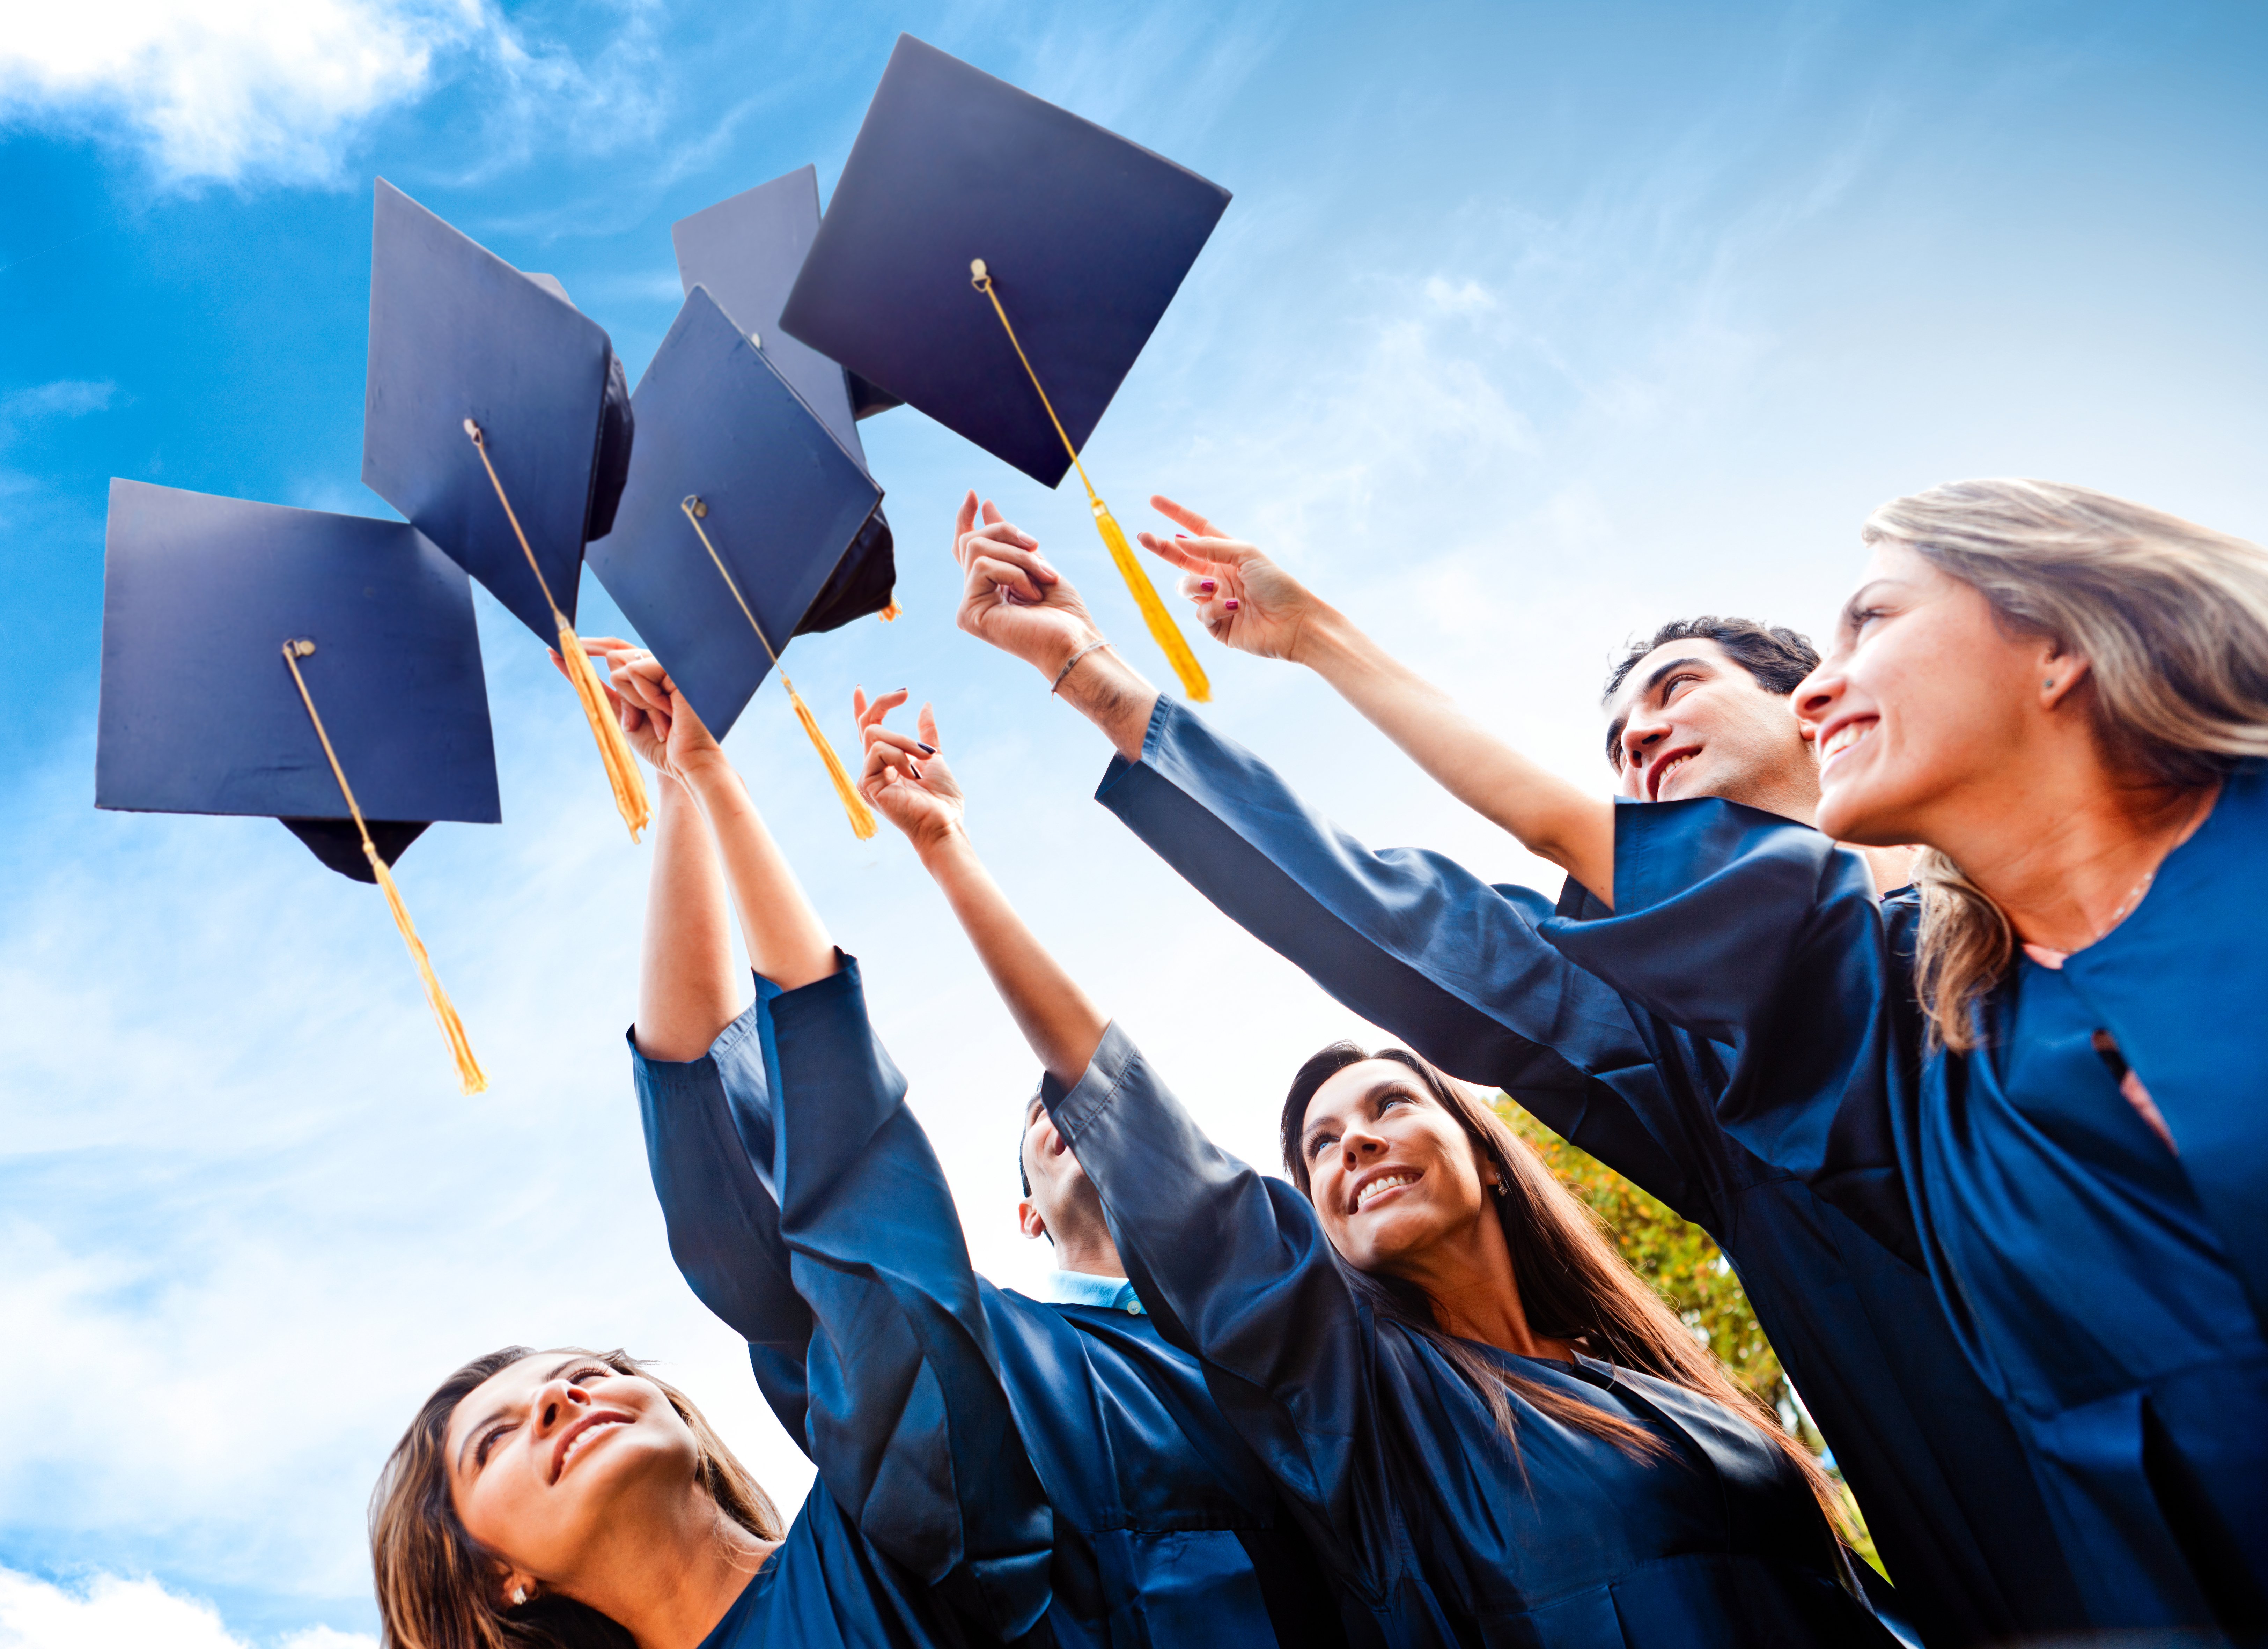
[{"xmin": 590, "ymin": 286, "xmax": 882, "ymax": 839}]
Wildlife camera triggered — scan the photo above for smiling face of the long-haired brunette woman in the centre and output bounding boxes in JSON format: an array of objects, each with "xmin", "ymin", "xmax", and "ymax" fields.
[{"xmin": 1299, "ymin": 1059, "xmax": 1497, "ymax": 1277}]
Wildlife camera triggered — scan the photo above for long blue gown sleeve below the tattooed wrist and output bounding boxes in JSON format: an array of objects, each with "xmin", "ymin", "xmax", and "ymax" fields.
[{"xmin": 1096, "ymin": 696, "xmax": 1715, "ymax": 1222}]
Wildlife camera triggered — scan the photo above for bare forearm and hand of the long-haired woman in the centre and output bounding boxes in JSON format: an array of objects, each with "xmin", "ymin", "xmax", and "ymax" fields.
[{"xmin": 853, "ymin": 692, "xmax": 1107, "ymax": 1087}]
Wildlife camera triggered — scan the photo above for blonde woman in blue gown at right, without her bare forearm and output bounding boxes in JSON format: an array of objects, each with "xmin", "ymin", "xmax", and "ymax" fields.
[{"xmin": 1549, "ymin": 481, "xmax": 2268, "ymax": 1642}]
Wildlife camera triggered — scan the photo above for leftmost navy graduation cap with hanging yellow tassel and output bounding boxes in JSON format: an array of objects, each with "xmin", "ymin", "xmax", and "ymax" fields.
[{"xmin": 95, "ymin": 481, "xmax": 503, "ymax": 1093}]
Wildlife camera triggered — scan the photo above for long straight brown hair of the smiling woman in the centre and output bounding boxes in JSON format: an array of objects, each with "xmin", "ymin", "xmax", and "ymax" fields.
[{"xmin": 1281, "ymin": 1041, "xmax": 1844, "ymax": 1531}]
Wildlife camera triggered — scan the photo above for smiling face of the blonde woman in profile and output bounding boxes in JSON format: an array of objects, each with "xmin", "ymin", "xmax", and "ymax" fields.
[{"xmin": 1796, "ymin": 542, "xmax": 2084, "ymax": 846}]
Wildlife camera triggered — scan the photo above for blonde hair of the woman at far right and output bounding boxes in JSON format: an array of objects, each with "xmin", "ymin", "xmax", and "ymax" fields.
[{"xmin": 1860, "ymin": 481, "xmax": 2268, "ymax": 1052}]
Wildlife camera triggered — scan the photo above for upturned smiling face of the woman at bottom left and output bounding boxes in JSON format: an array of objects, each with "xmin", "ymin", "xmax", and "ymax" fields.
[{"xmin": 447, "ymin": 1352, "xmax": 699, "ymax": 1595}]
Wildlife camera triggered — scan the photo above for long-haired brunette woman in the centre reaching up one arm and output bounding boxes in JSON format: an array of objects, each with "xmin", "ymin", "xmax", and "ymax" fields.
[{"xmin": 862, "ymin": 701, "xmax": 1892, "ymax": 1649}]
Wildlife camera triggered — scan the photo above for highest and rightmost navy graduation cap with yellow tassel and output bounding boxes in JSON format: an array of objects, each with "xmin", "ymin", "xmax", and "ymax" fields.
[{"xmin": 780, "ymin": 34, "xmax": 1229, "ymax": 701}]
